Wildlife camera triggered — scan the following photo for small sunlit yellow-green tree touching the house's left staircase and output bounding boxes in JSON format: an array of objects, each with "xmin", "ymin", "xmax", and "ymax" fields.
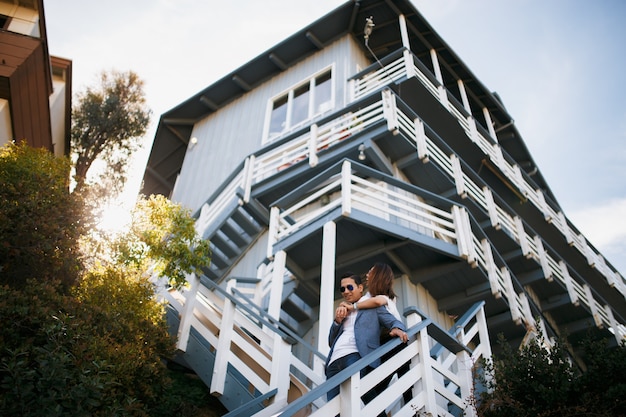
[{"xmin": 115, "ymin": 195, "xmax": 210, "ymax": 288}]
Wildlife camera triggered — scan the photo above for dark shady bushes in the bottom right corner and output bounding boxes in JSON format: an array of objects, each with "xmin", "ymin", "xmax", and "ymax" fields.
[{"xmin": 477, "ymin": 337, "xmax": 626, "ymax": 417}]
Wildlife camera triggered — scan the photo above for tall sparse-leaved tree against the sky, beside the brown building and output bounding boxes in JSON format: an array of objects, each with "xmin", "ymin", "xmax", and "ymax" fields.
[{"xmin": 71, "ymin": 71, "xmax": 151, "ymax": 196}]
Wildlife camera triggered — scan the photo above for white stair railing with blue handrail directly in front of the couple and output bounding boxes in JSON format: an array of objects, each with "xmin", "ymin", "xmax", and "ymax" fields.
[{"xmin": 277, "ymin": 303, "xmax": 491, "ymax": 417}]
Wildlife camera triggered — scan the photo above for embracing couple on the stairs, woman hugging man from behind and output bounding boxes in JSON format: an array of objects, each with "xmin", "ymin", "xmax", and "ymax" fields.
[{"xmin": 326, "ymin": 263, "xmax": 408, "ymax": 402}]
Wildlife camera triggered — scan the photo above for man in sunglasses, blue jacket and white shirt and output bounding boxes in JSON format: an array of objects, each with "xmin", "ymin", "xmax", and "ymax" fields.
[{"xmin": 326, "ymin": 274, "xmax": 408, "ymax": 402}]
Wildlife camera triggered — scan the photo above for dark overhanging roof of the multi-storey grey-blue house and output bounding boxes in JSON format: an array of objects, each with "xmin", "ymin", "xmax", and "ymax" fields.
[{"xmin": 142, "ymin": 0, "xmax": 556, "ymax": 202}]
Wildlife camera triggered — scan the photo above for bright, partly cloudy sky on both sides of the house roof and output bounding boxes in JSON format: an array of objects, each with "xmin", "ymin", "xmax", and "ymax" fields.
[{"xmin": 44, "ymin": 0, "xmax": 626, "ymax": 275}]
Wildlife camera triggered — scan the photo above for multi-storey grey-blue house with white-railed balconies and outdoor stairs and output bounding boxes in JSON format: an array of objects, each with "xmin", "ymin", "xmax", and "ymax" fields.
[{"xmin": 143, "ymin": 0, "xmax": 626, "ymax": 416}]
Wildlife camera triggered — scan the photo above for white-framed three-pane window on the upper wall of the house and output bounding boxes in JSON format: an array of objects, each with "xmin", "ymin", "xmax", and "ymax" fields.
[{"xmin": 267, "ymin": 69, "xmax": 333, "ymax": 140}]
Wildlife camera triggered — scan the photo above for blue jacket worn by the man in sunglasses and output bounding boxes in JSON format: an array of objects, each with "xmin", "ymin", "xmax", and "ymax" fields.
[{"xmin": 326, "ymin": 306, "xmax": 406, "ymax": 368}]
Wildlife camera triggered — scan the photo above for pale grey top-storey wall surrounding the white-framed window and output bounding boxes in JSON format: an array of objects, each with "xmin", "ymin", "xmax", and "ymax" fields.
[{"xmin": 171, "ymin": 36, "xmax": 369, "ymax": 211}]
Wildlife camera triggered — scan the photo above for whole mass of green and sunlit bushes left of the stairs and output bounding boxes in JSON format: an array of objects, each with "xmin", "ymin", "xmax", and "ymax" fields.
[{"xmin": 0, "ymin": 145, "xmax": 211, "ymax": 417}]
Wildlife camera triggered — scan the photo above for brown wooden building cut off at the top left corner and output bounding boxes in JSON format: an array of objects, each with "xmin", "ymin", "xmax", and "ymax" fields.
[{"xmin": 0, "ymin": 0, "xmax": 72, "ymax": 156}]
